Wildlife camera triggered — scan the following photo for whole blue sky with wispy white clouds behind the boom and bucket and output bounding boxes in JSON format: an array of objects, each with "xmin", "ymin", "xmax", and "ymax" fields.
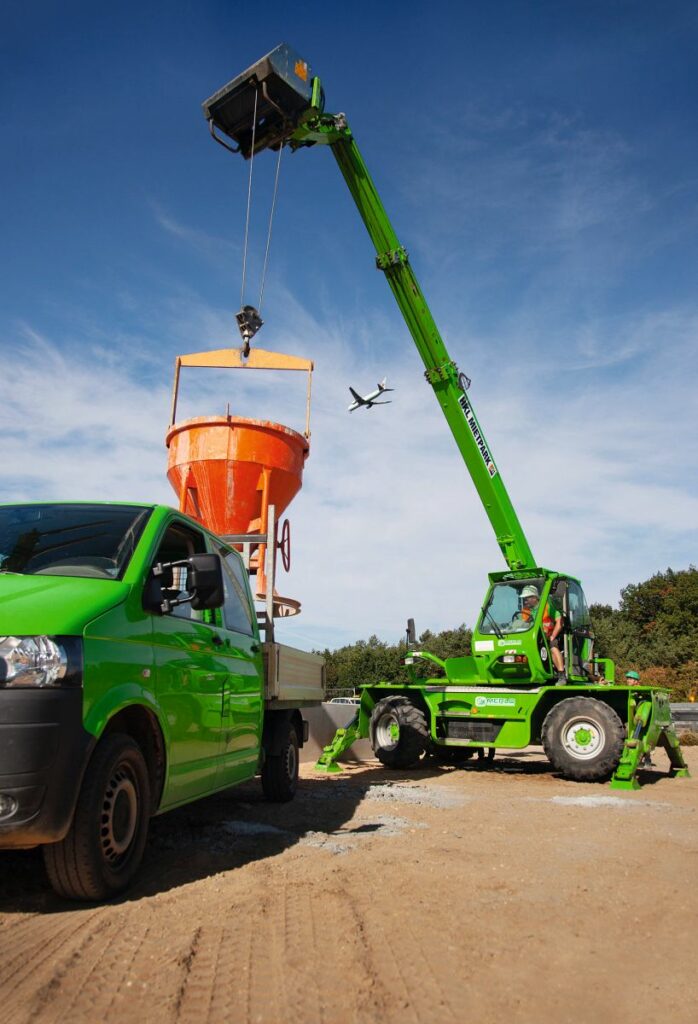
[{"xmin": 0, "ymin": 0, "xmax": 698, "ymax": 646}]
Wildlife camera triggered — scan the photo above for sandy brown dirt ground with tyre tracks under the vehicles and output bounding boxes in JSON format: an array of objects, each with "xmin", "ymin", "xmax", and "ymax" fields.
[{"xmin": 0, "ymin": 748, "xmax": 698, "ymax": 1024}]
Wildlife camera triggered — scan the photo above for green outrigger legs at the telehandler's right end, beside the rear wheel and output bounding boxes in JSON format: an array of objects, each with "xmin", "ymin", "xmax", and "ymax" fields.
[{"xmin": 611, "ymin": 692, "xmax": 690, "ymax": 790}]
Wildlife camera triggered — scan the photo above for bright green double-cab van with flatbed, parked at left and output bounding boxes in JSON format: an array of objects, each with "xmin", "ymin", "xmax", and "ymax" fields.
[{"xmin": 0, "ymin": 503, "xmax": 324, "ymax": 900}]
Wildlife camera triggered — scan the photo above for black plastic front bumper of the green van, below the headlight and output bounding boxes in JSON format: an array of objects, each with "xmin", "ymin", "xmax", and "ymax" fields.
[{"xmin": 0, "ymin": 687, "xmax": 94, "ymax": 849}]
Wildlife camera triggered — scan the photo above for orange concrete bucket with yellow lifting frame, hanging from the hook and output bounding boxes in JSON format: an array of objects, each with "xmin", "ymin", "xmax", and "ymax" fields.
[{"xmin": 166, "ymin": 349, "xmax": 313, "ymax": 616}]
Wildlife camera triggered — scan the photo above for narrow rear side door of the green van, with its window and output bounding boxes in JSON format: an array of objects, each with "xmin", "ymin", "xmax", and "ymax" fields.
[{"xmin": 213, "ymin": 549, "xmax": 264, "ymax": 785}]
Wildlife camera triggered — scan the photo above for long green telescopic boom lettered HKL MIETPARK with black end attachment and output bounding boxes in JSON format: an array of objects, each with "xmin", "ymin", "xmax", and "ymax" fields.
[{"xmin": 204, "ymin": 44, "xmax": 536, "ymax": 569}]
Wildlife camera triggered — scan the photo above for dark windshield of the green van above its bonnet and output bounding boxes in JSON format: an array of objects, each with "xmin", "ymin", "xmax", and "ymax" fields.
[{"xmin": 0, "ymin": 504, "xmax": 152, "ymax": 580}]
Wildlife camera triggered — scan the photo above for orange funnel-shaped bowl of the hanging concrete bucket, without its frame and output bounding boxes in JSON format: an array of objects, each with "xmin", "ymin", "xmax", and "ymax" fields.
[{"xmin": 166, "ymin": 416, "xmax": 309, "ymax": 537}]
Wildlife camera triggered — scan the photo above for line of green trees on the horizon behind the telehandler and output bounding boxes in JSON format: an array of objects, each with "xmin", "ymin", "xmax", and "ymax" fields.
[{"xmin": 321, "ymin": 565, "xmax": 698, "ymax": 700}]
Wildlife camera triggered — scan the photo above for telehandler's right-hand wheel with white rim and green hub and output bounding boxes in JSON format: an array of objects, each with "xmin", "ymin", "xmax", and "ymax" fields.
[{"xmin": 541, "ymin": 697, "xmax": 625, "ymax": 782}]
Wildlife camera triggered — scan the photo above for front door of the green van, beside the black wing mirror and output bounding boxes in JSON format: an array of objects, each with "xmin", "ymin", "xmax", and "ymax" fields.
[{"xmin": 148, "ymin": 521, "xmax": 228, "ymax": 807}]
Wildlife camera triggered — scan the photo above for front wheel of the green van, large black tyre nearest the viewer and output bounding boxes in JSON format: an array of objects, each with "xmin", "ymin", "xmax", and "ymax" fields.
[{"xmin": 43, "ymin": 732, "xmax": 150, "ymax": 900}]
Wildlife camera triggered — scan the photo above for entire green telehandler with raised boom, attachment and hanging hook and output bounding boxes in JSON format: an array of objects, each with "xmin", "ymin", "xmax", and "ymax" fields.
[{"xmin": 203, "ymin": 44, "xmax": 688, "ymax": 788}]
